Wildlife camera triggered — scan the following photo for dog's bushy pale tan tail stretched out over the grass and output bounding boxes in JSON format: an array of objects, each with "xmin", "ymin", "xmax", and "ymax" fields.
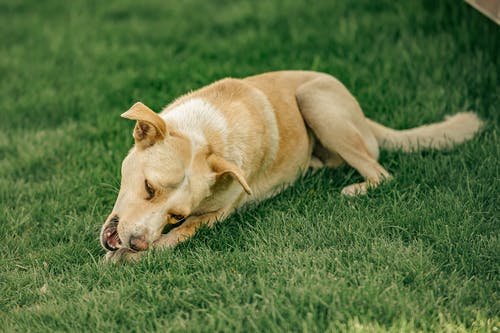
[{"xmin": 367, "ymin": 112, "xmax": 483, "ymax": 152}]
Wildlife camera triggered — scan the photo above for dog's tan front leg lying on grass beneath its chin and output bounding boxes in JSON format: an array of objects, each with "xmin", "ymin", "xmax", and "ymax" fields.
[{"xmin": 153, "ymin": 211, "xmax": 226, "ymax": 249}]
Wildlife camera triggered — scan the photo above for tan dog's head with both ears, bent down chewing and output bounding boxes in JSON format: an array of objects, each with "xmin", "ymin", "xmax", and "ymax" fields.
[{"xmin": 101, "ymin": 102, "xmax": 250, "ymax": 251}]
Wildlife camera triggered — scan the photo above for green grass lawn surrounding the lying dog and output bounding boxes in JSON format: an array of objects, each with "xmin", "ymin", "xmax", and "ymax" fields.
[{"xmin": 0, "ymin": 0, "xmax": 500, "ymax": 332}]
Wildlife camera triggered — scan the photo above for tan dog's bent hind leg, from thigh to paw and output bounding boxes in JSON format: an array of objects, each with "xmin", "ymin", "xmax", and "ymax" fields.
[{"xmin": 296, "ymin": 75, "xmax": 390, "ymax": 195}]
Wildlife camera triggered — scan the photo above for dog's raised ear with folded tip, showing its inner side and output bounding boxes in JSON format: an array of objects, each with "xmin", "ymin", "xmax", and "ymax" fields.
[{"xmin": 121, "ymin": 102, "xmax": 167, "ymax": 148}]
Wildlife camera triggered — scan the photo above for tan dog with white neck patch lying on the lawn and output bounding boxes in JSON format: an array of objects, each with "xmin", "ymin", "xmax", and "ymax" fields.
[{"xmin": 101, "ymin": 71, "xmax": 481, "ymax": 262}]
